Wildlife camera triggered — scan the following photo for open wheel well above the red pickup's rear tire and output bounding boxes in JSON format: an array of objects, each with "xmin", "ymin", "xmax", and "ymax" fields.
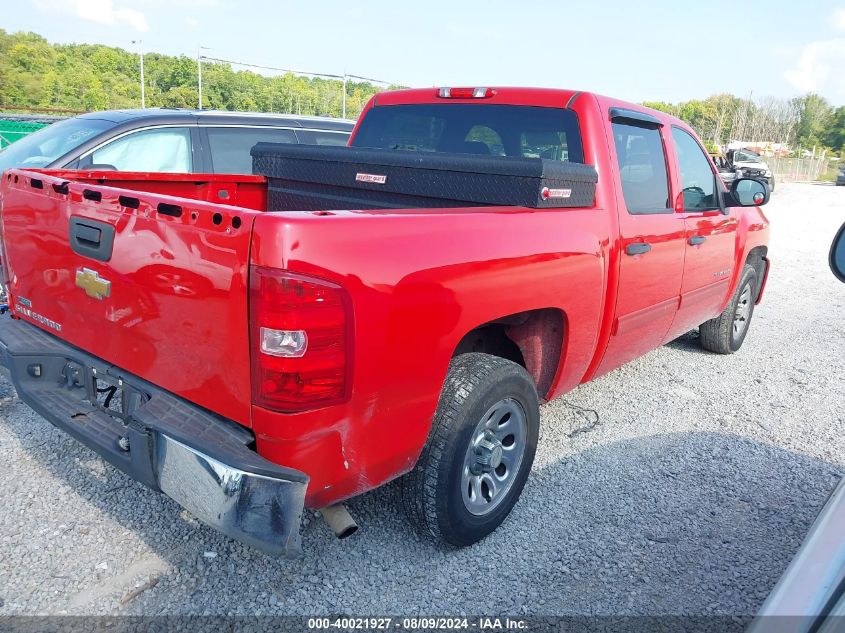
[{"xmin": 454, "ymin": 308, "xmax": 564, "ymax": 398}]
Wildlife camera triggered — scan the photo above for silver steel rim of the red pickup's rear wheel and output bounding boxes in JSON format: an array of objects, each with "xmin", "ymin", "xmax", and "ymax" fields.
[{"xmin": 461, "ymin": 398, "xmax": 528, "ymax": 516}]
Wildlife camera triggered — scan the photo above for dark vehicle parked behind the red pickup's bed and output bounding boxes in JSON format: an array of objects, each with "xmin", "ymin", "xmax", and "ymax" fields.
[{"xmin": 0, "ymin": 108, "xmax": 354, "ymax": 174}]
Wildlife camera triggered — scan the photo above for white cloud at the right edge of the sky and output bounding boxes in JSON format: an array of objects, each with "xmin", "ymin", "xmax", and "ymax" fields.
[{"xmin": 783, "ymin": 38, "xmax": 845, "ymax": 101}]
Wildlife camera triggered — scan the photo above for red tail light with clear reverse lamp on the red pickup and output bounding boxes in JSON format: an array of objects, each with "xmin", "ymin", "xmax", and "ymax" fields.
[{"xmin": 249, "ymin": 266, "xmax": 352, "ymax": 412}]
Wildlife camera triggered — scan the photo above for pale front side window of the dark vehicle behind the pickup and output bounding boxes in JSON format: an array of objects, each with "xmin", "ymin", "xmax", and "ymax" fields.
[{"xmin": 88, "ymin": 127, "xmax": 193, "ymax": 173}]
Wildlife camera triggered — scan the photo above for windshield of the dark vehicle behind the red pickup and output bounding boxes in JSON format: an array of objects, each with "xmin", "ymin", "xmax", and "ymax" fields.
[{"xmin": 0, "ymin": 118, "xmax": 114, "ymax": 172}]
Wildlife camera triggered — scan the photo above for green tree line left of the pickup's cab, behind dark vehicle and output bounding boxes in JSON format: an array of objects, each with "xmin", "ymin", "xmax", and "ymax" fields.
[{"xmin": 0, "ymin": 29, "xmax": 384, "ymax": 118}]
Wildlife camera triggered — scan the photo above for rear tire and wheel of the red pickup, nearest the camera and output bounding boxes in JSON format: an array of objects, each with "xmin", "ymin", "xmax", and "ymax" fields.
[{"xmin": 400, "ymin": 353, "xmax": 540, "ymax": 547}]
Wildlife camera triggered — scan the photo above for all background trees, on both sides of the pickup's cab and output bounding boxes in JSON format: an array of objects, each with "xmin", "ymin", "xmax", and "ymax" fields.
[{"xmin": 0, "ymin": 29, "xmax": 845, "ymax": 153}]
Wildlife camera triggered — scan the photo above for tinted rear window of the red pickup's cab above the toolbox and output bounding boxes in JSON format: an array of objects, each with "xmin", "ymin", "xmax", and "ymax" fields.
[{"xmin": 352, "ymin": 103, "xmax": 584, "ymax": 163}]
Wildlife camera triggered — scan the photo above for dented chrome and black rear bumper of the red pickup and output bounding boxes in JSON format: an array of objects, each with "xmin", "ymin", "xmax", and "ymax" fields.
[{"xmin": 0, "ymin": 317, "xmax": 308, "ymax": 556}]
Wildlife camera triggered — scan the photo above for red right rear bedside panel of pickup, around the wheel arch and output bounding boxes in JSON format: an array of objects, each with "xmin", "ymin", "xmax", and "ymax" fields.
[{"xmin": 247, "ymin": 208, "xmax": 610, "ymax": 507}]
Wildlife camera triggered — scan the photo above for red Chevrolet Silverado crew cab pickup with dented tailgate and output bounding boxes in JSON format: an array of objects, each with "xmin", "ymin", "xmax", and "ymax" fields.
[{"xmin": 0, "ymin": 88, "xmax": 769, "ymax": 554}]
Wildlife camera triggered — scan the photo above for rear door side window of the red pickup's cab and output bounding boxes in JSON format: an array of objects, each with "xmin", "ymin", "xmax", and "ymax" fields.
[{"xmin": 613, "ymin": 123, "xmax": 672, "ymax": 214}]
